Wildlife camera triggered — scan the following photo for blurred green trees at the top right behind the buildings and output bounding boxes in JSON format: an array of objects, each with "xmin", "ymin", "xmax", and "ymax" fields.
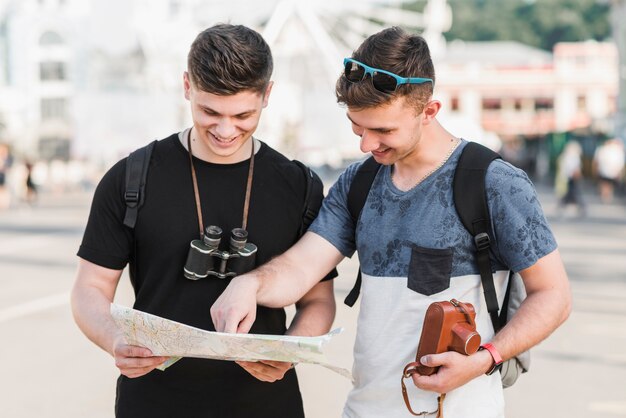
[{"xmin": 404, "ymin": 0, "xmax": 608, "ymax": 51}]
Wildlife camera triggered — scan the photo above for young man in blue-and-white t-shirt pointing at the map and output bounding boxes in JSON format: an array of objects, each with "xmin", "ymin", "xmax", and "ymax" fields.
[{"xmin": 211, "ymin": 28, "xmax": 571, "ymax": 418}]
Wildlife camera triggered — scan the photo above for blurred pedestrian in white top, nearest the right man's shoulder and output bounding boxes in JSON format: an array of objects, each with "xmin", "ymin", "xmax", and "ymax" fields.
[{"xmin": 555, "ymin": 141, "xmax": 586, "ymax": 215}]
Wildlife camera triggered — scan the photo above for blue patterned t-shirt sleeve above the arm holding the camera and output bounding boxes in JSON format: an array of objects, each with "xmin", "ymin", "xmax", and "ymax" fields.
[{"xmin": 485, "ymin": 160, "xmax": 557, "ymax": 272}]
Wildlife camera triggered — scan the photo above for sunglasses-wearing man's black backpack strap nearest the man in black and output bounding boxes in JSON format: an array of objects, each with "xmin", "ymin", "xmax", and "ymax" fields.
[{"xmin": 343, "ymin": 157, "xmax": 381, "ymax": 307}]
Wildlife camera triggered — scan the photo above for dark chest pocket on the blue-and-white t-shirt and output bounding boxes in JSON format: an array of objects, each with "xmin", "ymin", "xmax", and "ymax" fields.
[{"xmin": 407, "ymin": 245, "xmax": 453, "ymax": 296}]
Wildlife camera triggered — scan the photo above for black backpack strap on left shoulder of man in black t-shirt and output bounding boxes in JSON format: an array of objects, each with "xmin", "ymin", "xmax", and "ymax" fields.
[{"xmin": 124, "ymin": 141, "xmax": 157, "ymax": 228}]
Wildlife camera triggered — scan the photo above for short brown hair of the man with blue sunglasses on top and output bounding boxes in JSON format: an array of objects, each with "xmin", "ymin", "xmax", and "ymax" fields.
[{"xmin": 335, "ymin": 27, "xmax": 435, "ymax": 112}]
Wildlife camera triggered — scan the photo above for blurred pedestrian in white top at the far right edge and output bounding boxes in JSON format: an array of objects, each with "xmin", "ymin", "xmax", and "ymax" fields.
[{"xmin": 593, "ymin": 138, "xmax": 624, "ymax": 203}]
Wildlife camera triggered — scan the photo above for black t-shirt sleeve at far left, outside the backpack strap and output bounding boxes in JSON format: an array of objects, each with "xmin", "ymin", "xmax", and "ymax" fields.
[{"xmin": 77, "ymin": 160, "xmax": 133, "ymax": 270}]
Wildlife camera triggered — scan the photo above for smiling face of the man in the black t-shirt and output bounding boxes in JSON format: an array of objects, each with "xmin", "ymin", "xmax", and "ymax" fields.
[{"xmin": 184, "ymin": 73, "xmax": 272, "ymax": 164}]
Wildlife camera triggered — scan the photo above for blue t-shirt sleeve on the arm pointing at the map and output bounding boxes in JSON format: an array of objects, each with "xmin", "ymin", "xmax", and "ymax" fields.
[{"xmin": 309, "ymin": 163, "xmax": 360, "ymax": 257}]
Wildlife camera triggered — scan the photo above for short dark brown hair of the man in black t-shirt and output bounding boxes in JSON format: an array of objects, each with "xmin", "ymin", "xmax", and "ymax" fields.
[{"xmin": 187, "ymin": 24, "xmax": 274, "ymax": 96}]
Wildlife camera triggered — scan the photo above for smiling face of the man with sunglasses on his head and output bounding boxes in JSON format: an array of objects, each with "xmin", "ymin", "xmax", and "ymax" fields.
[{"xmin": 347, "ymin": 97, "xmax": 428, "ymax": 165}]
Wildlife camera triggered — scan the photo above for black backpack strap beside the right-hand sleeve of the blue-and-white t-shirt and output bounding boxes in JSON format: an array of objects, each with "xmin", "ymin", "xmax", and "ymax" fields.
[{"xmin": 452, "ymin": 142, "xmax": 506, "ymax": 332}]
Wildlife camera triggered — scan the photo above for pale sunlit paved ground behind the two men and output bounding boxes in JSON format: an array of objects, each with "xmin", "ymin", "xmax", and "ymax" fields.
[{"xmin": 0, "ymin": 180, "xmax": 626, "ymax": 418}]
